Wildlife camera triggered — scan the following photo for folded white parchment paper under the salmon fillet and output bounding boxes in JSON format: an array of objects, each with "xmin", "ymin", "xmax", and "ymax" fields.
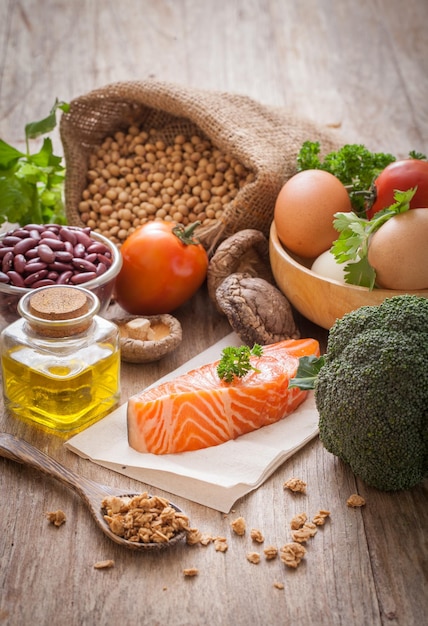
[{"xmin": 64, "ymin": 333, "xmax": 319, "ymax": 513}]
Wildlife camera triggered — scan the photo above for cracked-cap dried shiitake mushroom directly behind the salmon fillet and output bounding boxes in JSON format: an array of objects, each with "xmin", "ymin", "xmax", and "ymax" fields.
[{"xmin": 216, "ymin": 273, "xmax": 300, "ymax": 345}]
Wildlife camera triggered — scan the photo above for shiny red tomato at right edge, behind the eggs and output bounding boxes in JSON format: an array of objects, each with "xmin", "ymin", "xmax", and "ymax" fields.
[{"xmin": 366, "ymin": 159, "xmax": 428, "ymax": 219}]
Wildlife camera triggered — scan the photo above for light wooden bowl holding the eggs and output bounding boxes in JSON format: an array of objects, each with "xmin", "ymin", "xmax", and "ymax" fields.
[{"xmin": 269, "ymin": 223, "xmax": 428, "ymax": 330}]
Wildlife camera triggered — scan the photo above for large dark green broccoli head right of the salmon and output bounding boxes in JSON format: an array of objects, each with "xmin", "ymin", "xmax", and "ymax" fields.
[{"xmin": 315, "ymin": 295, "xmax": 428, "ymax": 491}]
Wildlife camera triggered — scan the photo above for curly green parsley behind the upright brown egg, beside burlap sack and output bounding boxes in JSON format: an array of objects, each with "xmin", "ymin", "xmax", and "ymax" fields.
[{"xmin": 297, "ymin": 141, "xmax": 396, "ymax": 215}]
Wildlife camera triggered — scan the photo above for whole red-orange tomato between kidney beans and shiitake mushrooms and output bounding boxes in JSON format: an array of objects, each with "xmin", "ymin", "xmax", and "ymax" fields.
[{"xmin": 115, "ymin": 221, "xmax": 208, "ymax": 315}]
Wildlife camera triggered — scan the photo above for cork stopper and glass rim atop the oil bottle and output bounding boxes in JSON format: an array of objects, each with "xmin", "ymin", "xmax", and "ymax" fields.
[{"xmin": 18, "ymin": 285, "xmax": 99, "ymax": 338}]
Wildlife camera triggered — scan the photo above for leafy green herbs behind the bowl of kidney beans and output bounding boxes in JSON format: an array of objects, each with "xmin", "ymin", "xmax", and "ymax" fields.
[{"xmin": 0, "ymin": 100, "xmax": 69, "ymax": 225}]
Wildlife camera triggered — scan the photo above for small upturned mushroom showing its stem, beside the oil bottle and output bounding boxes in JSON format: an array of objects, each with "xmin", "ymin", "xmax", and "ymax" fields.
[{"xmin": 112, "ymin": 314, "xmax": 182, "ymax": 363}]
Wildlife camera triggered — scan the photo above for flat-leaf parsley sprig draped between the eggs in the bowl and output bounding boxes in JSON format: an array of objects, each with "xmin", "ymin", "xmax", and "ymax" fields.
[{"xmin": 331, "ymin": 187, "xmax": 416, "ymax": 289}]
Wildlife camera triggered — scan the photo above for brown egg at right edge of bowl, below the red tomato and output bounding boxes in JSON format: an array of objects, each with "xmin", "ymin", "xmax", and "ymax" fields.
[{"xmin": 368, "ymin": 208, "xmax": 428, "ymax": 291}]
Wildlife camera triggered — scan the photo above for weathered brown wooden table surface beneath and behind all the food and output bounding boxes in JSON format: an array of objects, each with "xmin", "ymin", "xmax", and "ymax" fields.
[{"xmin": 0, "ymin": 0, "xmax": 428, "ymax": 626}]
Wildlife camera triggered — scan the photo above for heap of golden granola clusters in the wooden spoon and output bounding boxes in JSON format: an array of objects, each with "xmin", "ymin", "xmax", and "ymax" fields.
[{"xmin": 101, "ymin": 492, "xmax": 189, "ymax": 543}]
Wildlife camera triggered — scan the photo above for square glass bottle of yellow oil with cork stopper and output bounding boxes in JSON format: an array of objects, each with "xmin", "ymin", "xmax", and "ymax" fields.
[{"xmin": 0, "ymin": 285, "xmax": 120, "ymax": 435}]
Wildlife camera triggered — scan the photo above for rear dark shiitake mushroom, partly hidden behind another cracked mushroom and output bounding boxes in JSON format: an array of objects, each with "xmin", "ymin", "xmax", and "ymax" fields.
[{"xmin": 207, "ymin": 228, "xmax": 275, "ymax": 309}]
